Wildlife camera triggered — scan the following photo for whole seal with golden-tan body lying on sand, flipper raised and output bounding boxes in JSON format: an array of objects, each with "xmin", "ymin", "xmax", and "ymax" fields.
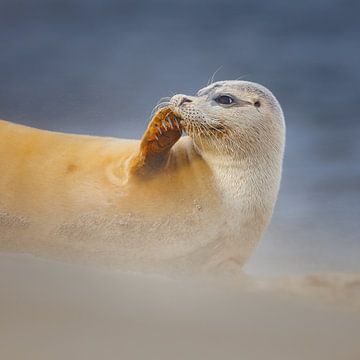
[{"xmin": 0, "ymin": 81, "xmax": 285, "ymax": 273}]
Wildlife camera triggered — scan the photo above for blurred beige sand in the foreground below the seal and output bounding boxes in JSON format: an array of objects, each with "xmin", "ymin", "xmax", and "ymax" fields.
[{"xmin": 0, "ymin": 255, "xmax": 360, "ymax": 360}]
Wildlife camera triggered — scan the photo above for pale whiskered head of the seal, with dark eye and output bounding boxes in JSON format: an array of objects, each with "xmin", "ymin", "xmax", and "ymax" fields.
[{"xmin": 170, "ymin": 80, "xmax": 284, "ymax": 157}]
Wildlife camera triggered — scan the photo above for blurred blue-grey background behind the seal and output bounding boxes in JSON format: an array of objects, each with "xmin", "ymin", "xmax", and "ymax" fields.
[{"xmin": 0, "ymin": 0, "xmax": 360, "ymax": 274}]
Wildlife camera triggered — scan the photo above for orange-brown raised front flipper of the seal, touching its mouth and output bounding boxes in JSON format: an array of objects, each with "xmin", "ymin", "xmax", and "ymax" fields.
[{"xmin": 129, "ymin": 108, "xmax": 182, "ymax": 175}]
